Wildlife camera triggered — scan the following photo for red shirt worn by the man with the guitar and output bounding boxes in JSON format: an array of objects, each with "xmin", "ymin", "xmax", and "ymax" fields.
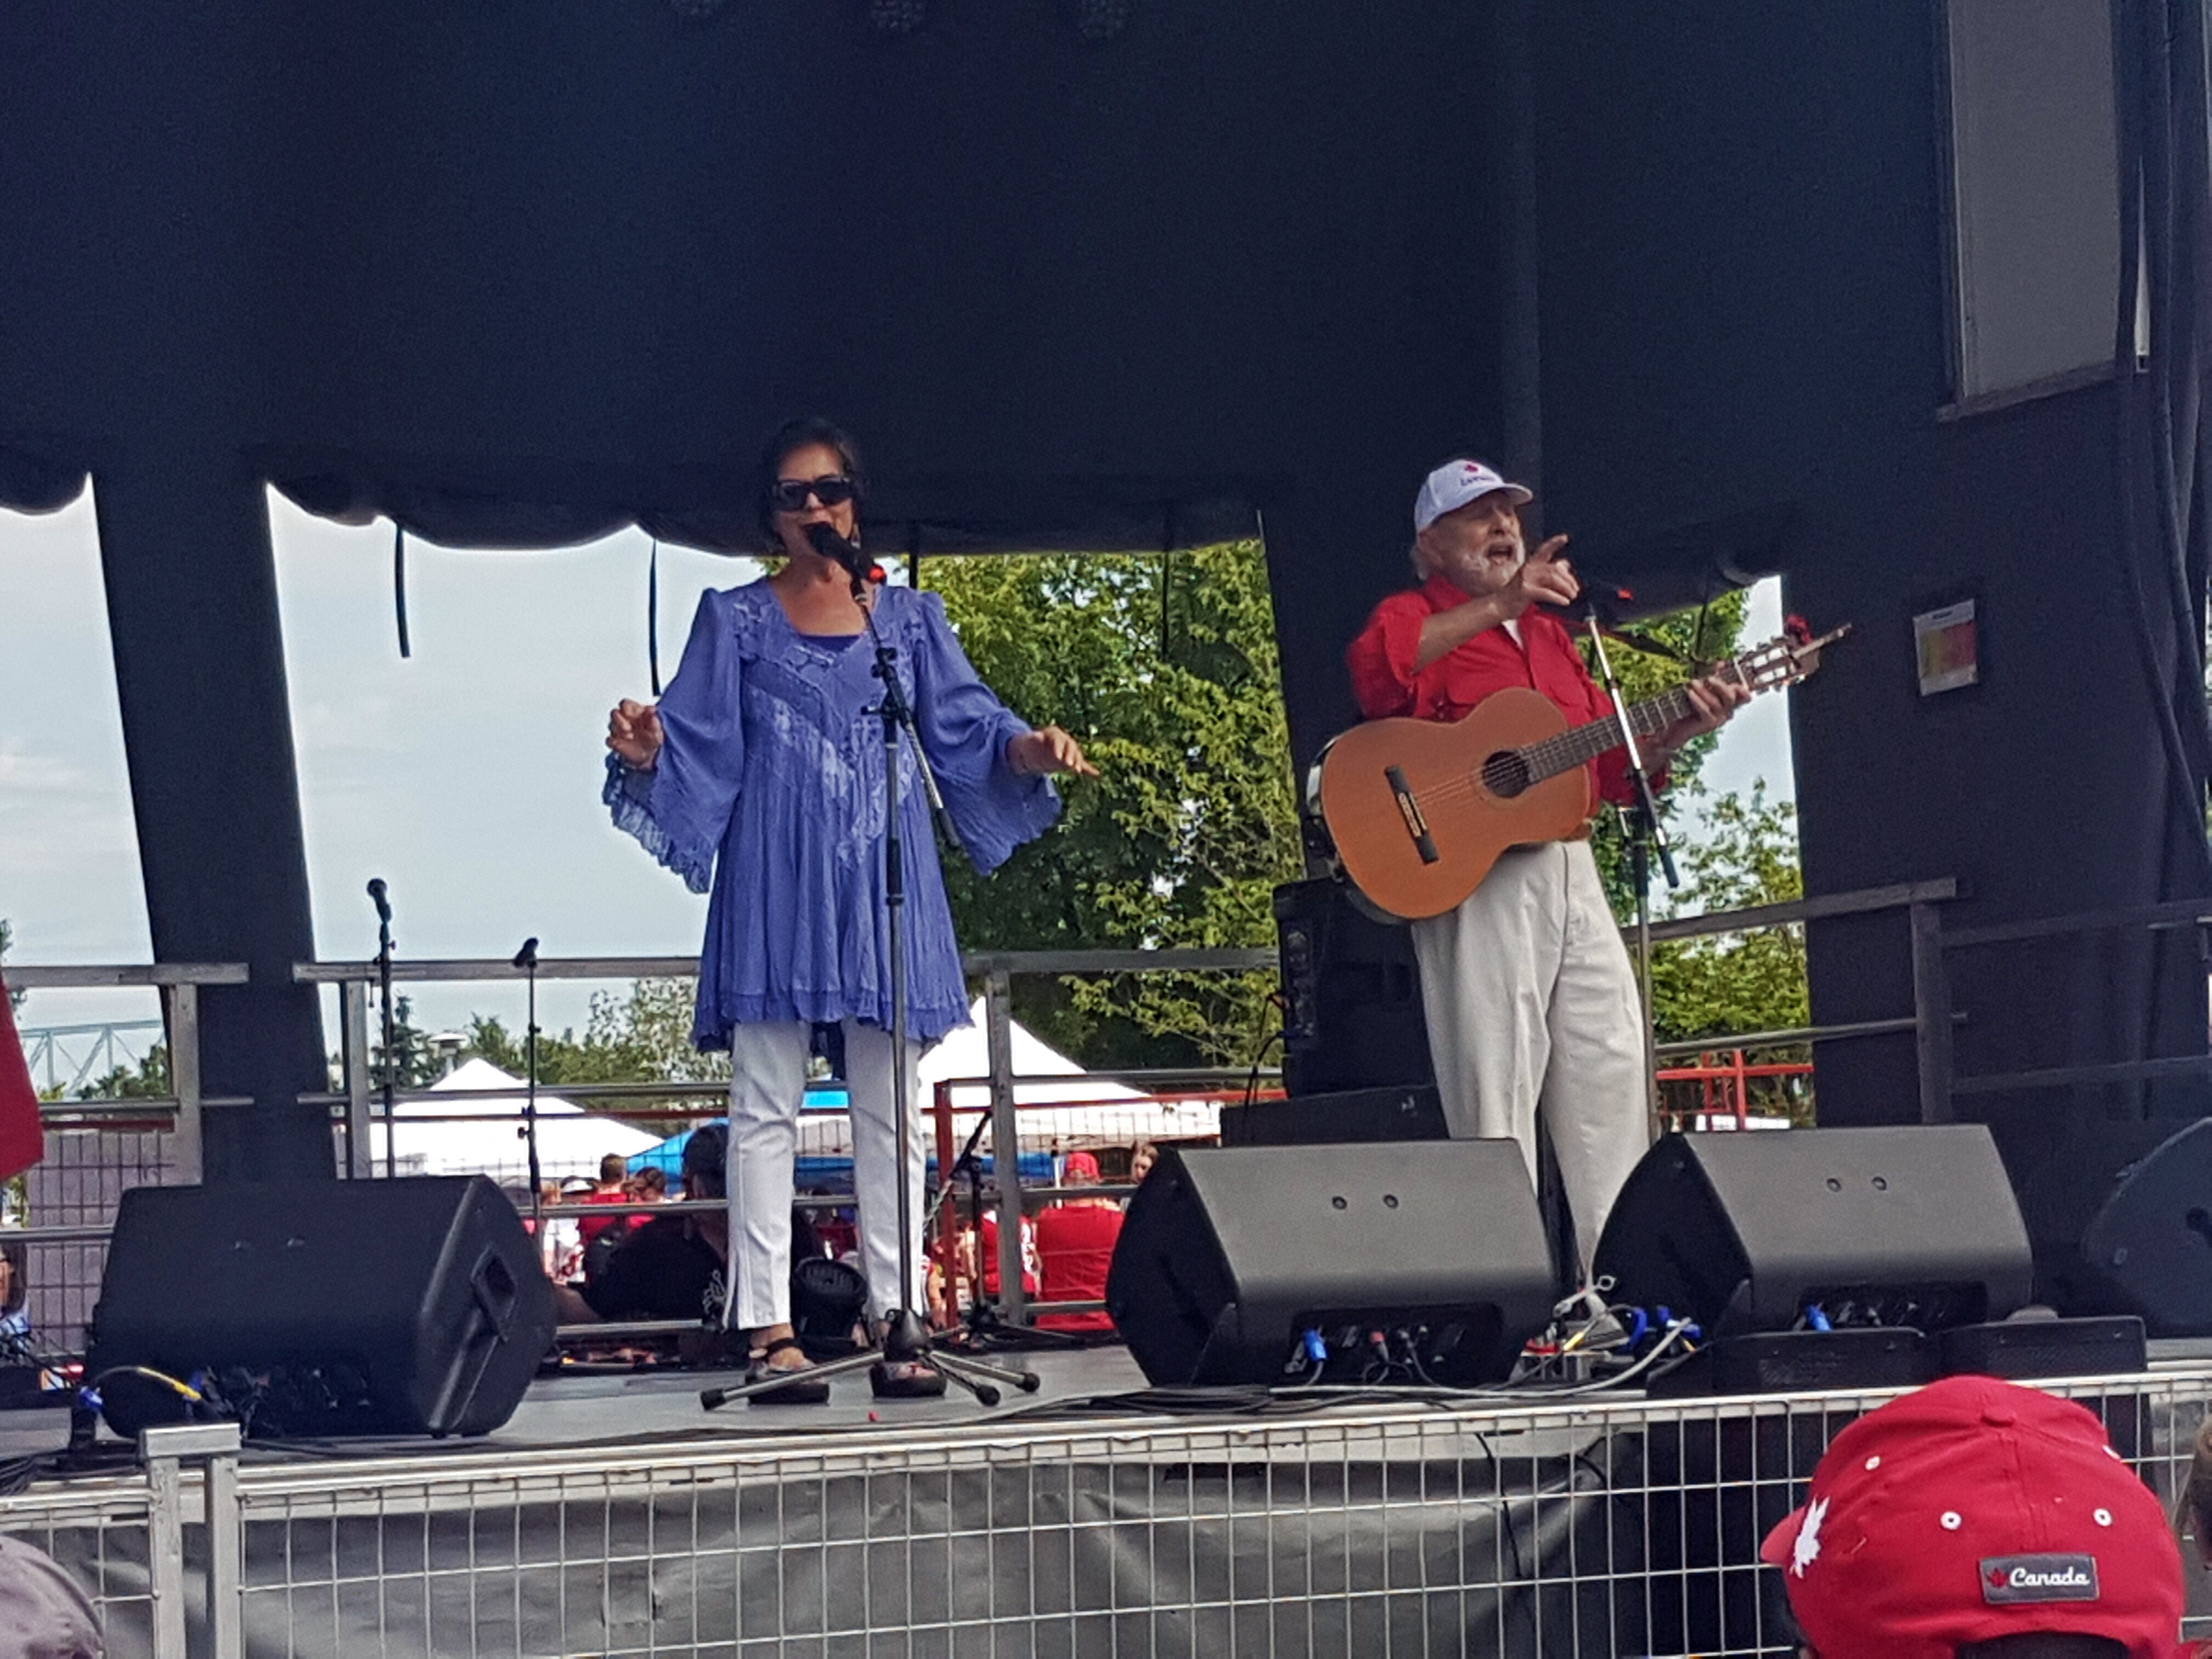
[{"xmin": 1347, "ymin": 575, "xmax": 1663, "ymax": 805}]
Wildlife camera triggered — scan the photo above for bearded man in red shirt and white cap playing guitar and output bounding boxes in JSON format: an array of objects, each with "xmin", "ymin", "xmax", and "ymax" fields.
[{"xmin": 1347, "ymin": 458, "xmax": 1750, "ymax": 1259}]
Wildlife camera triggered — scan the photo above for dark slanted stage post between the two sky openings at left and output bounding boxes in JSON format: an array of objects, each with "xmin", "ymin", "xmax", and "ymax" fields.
[{"xmin": 95, "ymin": 455, "xmax": 334, "ymax": 1181}]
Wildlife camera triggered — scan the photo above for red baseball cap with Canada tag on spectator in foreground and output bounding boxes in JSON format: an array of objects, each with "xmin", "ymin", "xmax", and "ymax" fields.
[{"xmin": 1758, "ymin": 1376, "xmax": 2183, "ymax": 1659}]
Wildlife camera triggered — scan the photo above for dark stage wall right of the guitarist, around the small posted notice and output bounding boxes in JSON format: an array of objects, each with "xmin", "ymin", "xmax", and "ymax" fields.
[{"xmin": 1542, "ymin": 0, "xmax": 2205, "ymax": 1159}]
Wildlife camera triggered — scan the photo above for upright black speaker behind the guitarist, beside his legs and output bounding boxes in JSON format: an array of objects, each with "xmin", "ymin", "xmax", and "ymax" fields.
[{"xmin": 1274, "ymin": 881, "xmax": 1436, "ymax": 1095}]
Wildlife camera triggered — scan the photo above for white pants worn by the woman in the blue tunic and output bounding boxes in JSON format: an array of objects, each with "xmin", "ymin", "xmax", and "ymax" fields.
[{"xmin": 728, "ymin": 1020, "xmax": 924, "ymax": 1331}]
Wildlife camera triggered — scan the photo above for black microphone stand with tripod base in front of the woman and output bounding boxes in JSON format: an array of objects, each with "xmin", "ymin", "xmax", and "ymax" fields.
[{"xmin": 699, "ymin": 538, "xmax": 1040, "ymax": 1411}]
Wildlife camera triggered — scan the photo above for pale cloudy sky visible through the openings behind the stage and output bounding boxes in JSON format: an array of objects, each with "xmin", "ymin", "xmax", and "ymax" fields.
[{"xmin": 0, "ymin": 491, "xmax": 1792, "ymax": 1033}]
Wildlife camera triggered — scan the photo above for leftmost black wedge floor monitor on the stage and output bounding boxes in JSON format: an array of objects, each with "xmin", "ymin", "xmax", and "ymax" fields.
[{"xmin": 84, "ymin": 1175, "xmax": 555, "ymax": 1438}]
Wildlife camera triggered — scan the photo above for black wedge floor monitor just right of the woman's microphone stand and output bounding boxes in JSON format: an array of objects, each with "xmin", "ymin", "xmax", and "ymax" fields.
[{"xmin": 1106, "ymin": 1142, "xmax": 1555, "ymax": 1387}]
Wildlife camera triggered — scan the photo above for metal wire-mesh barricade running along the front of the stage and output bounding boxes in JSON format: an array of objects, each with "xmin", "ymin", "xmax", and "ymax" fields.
[{"xmin": 0, "ymin": 1372, "xmax": 2212, "ymax": 1659}]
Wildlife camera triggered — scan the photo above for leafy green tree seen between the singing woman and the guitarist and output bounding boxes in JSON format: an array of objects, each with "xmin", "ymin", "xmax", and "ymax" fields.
[{"xmin": 924, "ymin": 542, "xmax": 1303, "ymax": 1064}]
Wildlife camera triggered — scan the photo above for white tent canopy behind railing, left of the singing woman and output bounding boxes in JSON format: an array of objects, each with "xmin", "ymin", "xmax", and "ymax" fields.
[{"xmin": 369, "ymin": 1059, "xmax": 662, "ymax": 1183}]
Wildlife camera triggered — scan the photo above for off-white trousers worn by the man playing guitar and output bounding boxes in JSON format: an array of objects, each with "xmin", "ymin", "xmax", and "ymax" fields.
[{"xmin": 1413, "ymin": 840, "xmax": 1650, "ymax": 1263}]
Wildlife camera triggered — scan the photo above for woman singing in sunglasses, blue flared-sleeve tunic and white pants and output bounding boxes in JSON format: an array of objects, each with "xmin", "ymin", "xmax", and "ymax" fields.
[{"xmin": 606, "ymin": 420, "xmax": 1095, "ymax": 1400}]
